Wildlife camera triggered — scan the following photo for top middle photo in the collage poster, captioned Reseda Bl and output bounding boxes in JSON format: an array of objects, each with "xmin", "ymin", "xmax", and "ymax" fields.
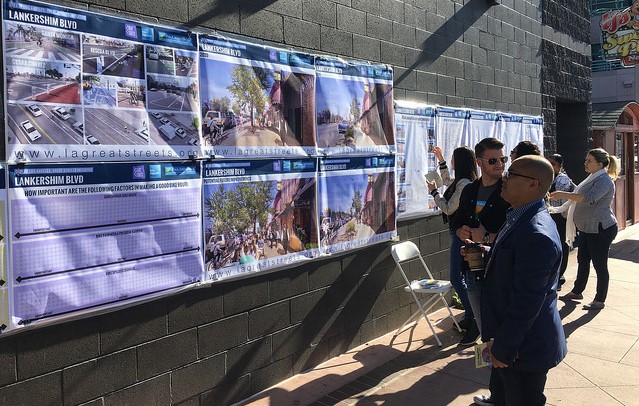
[{"xmin": 82, "ymin": 35, "xmax": 144, "ymax": 79}]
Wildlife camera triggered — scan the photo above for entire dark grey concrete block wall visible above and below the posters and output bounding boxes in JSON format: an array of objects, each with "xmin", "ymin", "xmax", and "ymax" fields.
[{"xmin": 0, "ymin": 0, "xmax": 584, "ymax": 406}]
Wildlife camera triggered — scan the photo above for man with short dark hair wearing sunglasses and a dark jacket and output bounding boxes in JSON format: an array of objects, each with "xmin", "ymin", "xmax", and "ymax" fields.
[{"xmin": 451, "ymin": 138, "xmax": 510, "ymax": 345}]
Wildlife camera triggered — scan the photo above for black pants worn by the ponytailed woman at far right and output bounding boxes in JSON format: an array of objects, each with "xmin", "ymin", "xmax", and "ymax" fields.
[{"xmin": 572, "ymin": 224, "xmax": 617, "ymax": 302}]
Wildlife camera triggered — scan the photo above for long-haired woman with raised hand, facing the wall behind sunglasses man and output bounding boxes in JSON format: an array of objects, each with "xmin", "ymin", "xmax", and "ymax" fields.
[{"xmin": 426, "ymin": 147, "xmax": 477, "ymax": 330}]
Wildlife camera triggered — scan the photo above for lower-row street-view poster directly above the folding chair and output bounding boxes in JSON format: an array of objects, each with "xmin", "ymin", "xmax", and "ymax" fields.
[{"xmin": 318, "ymin": 155, "xmax": 397, "ymax": 254}]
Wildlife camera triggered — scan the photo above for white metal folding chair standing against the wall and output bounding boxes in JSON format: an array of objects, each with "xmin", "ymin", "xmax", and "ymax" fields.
[{"xmin": 391, "ymin": 241, "xmax": 462, "ymax": 347}]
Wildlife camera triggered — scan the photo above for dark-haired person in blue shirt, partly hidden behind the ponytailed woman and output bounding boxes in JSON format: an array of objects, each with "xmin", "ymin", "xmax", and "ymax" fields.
[{"xmin": 546, "ymin": 154, "xmax": 576, "ymax": 290}]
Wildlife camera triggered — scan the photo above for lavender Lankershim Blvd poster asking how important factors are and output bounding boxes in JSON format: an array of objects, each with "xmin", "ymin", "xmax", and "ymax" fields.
[{"xmin": 8, "ymin": 161, "xmax": 203, "ymax": 326}]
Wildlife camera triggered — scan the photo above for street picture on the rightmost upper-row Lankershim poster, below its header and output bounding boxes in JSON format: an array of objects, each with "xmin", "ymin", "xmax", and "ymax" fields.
[{"xmin": 316, "ymin": 76, "xmax": 394, "ymax": 148}]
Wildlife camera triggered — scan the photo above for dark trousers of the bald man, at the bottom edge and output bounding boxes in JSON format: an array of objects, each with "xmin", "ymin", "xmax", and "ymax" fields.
[{"xmin": 489, "ymin": 368, "xmax": 548, "ymax": 406}]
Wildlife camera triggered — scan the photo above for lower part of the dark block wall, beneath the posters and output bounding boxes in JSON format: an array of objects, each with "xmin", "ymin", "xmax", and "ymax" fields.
[{"xmin": 0, "ymin": 216, "xmax": 450, "ymax": 406}]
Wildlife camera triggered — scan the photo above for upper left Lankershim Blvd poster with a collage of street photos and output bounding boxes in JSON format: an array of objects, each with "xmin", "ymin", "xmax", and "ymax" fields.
[{"xmin": 3, "ymin": 0, "xmax": 200, "ymax": 162}]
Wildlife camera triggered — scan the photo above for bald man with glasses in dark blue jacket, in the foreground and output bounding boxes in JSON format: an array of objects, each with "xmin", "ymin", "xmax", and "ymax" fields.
[{"xmin": 481, "ymin": 156, "xmax": 567, "ymax": 406}]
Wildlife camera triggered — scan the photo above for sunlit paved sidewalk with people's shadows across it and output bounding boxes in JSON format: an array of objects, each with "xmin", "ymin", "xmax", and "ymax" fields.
[{"xmin": 242, "ymin": 225, "xmax": 639, "ymax": 406}]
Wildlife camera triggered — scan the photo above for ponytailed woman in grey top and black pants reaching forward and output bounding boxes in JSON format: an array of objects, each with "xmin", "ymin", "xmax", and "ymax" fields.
[{"xmin": 550, "ymin": 148, "xmax": 619, "ymax": 310}]
